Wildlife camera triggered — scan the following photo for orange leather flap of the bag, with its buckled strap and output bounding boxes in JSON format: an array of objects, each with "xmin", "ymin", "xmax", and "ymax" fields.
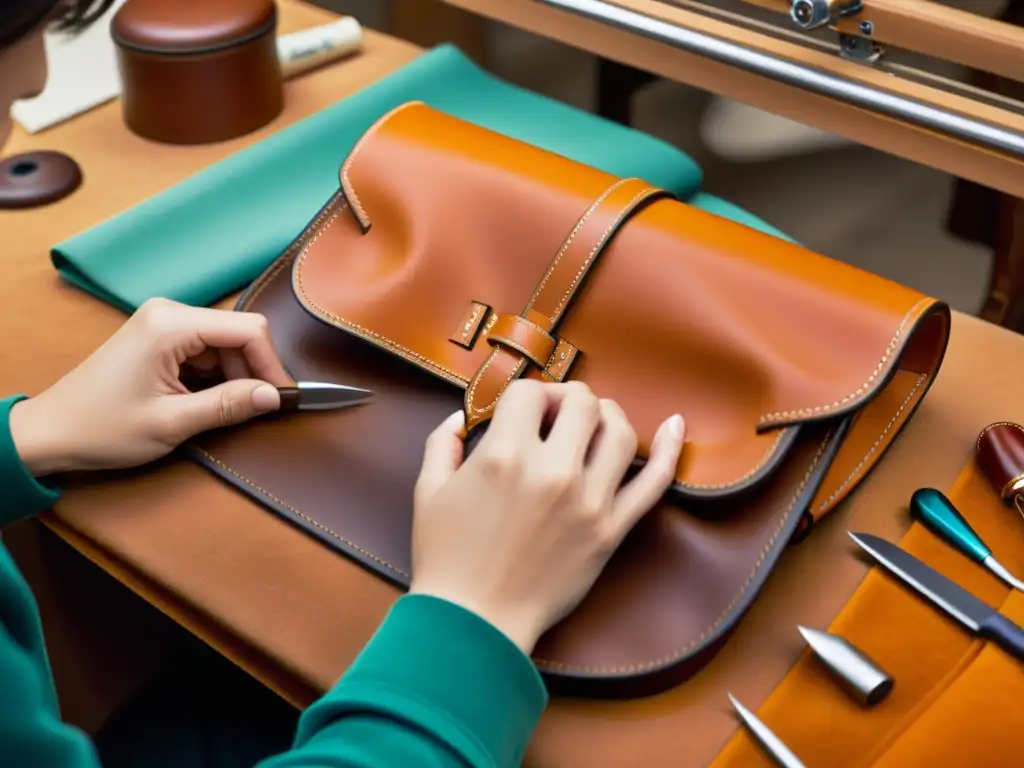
[{"xmin": 293, "ymin": 102, "xmax": 948, "ymax": 498}]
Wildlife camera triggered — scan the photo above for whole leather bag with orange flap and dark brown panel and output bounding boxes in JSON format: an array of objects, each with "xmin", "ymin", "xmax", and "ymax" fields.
[{"xmin": 193, "ymin": 102, "xmax": 949, "ymax": 696}]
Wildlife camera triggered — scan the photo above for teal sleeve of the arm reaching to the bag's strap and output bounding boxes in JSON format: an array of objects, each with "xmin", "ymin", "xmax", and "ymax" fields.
[{"xmin": 261, "ymin": 595, "xmax": 547, "ymax": 768}]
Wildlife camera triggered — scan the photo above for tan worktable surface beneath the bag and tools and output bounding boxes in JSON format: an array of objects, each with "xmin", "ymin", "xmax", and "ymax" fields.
[{"xmin": 0, "ymin": 0, "xmax": 1024, "ymax": 768}]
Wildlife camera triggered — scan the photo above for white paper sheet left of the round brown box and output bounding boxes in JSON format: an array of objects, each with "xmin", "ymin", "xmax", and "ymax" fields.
[{"xmin": 11, "ymin": 0, "xmax": 125, "ymax": 133}]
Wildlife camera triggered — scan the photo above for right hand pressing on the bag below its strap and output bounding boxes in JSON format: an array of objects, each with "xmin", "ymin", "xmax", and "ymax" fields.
[{"xmin": 411, "ymin": 380, "xmax": 683, "ymax": 654}]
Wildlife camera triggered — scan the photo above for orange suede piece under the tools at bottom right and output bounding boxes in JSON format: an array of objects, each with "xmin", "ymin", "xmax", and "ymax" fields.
[{"xmin": 712, "ymin": 462, "xmax": 1024, "ymax": 768}]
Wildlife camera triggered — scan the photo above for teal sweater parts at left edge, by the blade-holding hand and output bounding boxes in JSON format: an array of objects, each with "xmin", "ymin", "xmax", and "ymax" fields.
[{"xmin": 0, "ymin": 397, "xmax": 99, "ymax": 768}]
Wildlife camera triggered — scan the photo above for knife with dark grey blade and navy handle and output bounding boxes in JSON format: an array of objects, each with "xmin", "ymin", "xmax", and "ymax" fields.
[{"xmin": 848, "ymin": 531, "xmax": 1024, "ymax": 660}]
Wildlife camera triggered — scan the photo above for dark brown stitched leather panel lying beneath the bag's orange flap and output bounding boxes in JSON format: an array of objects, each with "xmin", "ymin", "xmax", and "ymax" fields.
[{"xmin": 193, "ymin": 230, "xmax": 840, "ymax": 695}]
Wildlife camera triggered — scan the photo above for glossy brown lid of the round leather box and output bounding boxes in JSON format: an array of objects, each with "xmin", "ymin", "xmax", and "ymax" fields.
[{"xmin": 111, "ymin": 0, "xmax": 276, "ymax": 53}]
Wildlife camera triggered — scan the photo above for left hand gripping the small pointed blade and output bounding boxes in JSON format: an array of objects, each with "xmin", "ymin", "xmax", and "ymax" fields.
[{"xmin": 10, "ymin": 299, "xmax": 293, "ymax": 476}]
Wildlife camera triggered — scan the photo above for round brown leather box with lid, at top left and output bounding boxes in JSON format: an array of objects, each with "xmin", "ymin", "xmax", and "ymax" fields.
[{"xmin": 111, "ymin": 0, "xmax": 285, "ymax": 144}]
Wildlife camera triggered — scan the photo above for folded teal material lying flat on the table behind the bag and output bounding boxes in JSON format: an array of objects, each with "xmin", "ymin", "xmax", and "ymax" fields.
[{"xmin": 51, "ymin": 45, "xmax": 700, "ymax": 311}]
